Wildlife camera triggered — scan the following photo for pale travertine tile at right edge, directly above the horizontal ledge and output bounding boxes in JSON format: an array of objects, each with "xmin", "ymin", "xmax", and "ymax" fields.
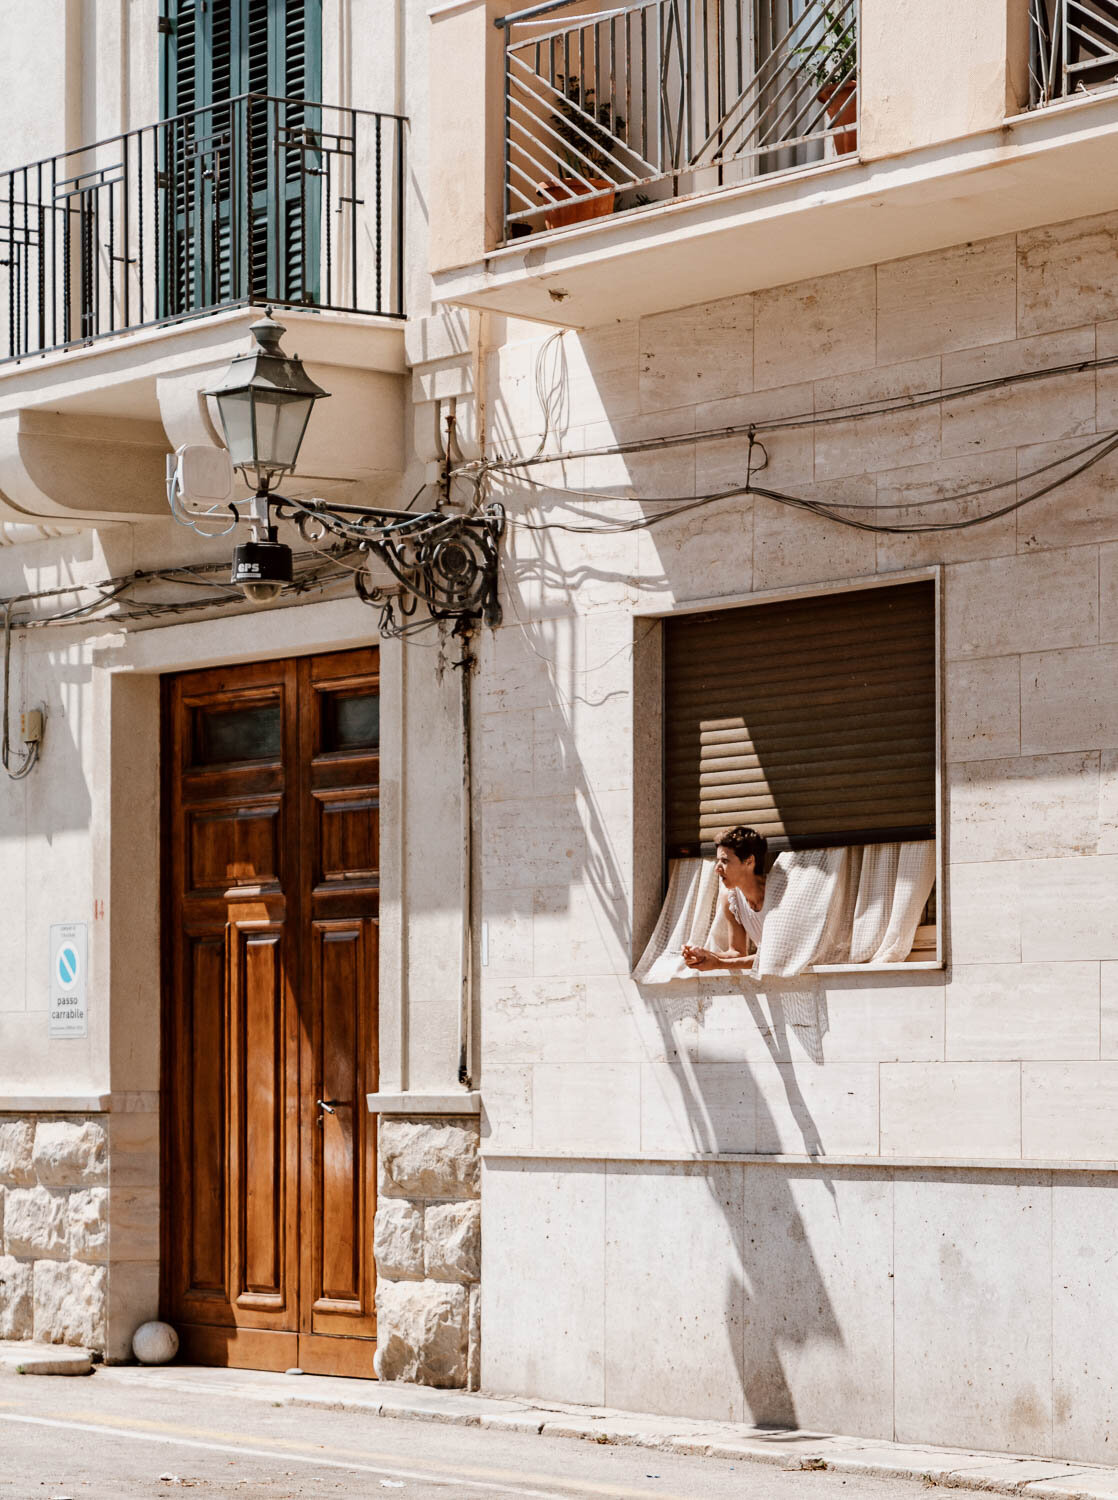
[{"xmin": 1020, "ymin": 1062, "xmax": 1118, "ymax": 1161}]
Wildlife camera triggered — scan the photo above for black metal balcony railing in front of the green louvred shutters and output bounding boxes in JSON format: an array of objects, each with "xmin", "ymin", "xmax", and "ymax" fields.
[{"xmin": 0, "ymin": 95, "xmax": 405, "ymax": 360}]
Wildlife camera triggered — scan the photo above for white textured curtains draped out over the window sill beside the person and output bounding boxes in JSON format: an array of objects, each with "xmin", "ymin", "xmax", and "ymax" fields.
[{"xmin": 635, "ymin": 840, "xmax": 935, "ymax": 984}]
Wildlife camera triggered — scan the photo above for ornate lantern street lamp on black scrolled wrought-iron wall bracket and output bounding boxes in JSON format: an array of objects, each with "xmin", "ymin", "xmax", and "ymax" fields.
[{"xmin": 192, "ymin": 308, "xmax": 504, "ymax": 635}]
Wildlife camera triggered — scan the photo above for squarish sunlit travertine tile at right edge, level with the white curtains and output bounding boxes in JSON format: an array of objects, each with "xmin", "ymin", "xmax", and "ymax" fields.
[{"xmin": 1017, "ymin": 855, "xmax": 1118, "ymax": 962}]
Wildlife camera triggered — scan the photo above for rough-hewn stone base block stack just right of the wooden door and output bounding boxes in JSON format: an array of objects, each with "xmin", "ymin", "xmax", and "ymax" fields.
[{"xmin": 374, "ymin": 1119, "xmax": 482, "ymax": 1391}]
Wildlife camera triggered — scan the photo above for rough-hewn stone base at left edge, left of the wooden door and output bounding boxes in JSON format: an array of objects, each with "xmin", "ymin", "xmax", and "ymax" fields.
[{"xmin": 0, "ymin": 1115, "xmax": 108, "ymax": 1350}]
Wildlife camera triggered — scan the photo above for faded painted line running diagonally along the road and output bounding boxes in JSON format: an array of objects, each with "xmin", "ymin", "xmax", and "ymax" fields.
[{"xmin": 0, "ymin": 1401, "xmax": 689, "ymax": 1500}]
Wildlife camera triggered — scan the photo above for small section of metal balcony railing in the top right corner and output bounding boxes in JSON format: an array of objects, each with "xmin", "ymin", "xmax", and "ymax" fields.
[{"xmin": 1029, "ymin": 0, "xmax": 1118, "ymax": 110}]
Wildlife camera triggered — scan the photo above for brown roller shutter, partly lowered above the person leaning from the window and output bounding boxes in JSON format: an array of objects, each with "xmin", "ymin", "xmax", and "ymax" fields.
[{"xmin": 665, "ymin": 581, "xmax": 936, "ymax": 854}]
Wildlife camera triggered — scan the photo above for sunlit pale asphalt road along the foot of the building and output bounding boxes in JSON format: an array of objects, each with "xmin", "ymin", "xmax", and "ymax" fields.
[{"xmin": 0, "ymin": 1371, "xmax": 917, "ymax": 1500}]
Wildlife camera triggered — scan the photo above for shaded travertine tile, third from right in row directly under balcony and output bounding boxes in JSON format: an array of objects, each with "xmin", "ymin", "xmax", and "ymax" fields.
[{"xmin": 753, "ymin": 266, "xmax": 876, "ymax": 390}]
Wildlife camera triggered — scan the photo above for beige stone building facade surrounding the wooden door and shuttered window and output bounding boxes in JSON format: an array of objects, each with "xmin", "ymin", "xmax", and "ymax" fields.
[{"xmin": 0, "ymin": 0, "xmax": 1118, "ymax": 1460}]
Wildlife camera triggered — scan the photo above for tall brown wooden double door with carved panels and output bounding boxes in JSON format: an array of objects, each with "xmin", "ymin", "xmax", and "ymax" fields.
[{"xmin": 162, "ymin": 650, "xmax": 380, "ymax": 1376}]
